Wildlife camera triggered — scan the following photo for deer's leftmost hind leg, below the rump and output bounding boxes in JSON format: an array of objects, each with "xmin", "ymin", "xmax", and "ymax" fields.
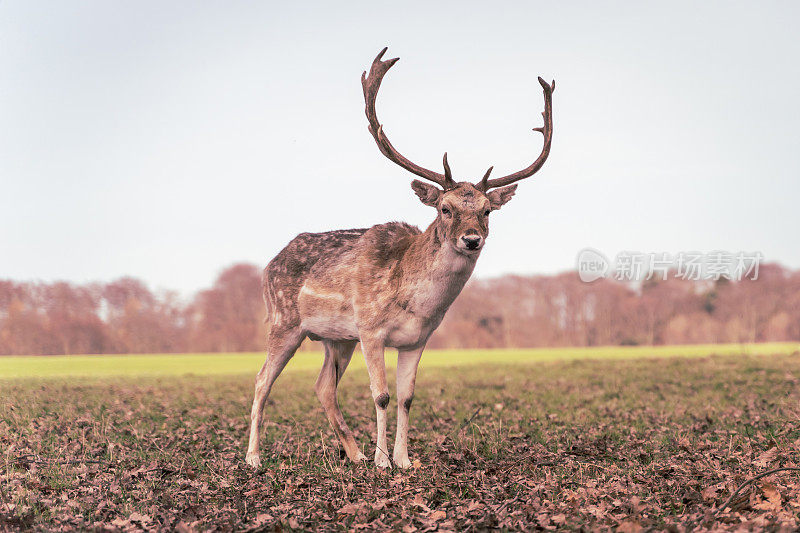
[{"xmin": 245, "ymin": 324, "xmax": 305, "ymax": 468}]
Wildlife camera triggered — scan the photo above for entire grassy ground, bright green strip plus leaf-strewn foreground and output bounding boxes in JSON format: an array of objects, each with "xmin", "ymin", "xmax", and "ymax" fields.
[{"xmin": 0, "ymin": 344, "xmax": 800, "ymax": 531}]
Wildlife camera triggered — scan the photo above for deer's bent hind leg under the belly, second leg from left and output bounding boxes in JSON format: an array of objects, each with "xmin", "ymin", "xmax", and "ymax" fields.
[{"xmin": 314, "ymin": 340, "xmax": 367, "ymax": 462}]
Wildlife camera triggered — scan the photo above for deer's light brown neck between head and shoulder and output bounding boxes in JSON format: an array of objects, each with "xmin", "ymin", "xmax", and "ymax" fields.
[{"xmin": 399, "ymin": 222, "xmax": 478, "ymax": 320}]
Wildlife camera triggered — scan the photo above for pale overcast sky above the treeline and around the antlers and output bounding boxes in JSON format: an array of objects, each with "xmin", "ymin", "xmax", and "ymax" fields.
[{"xmin": 0, "ymin": 0, "xmax": 800, "ymax": 295}]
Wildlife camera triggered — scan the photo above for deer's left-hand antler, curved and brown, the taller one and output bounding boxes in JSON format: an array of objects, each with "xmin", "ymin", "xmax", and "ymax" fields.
[{"xmin": 361, "ymin": 47, "xmax": 455, "ymax": 189}]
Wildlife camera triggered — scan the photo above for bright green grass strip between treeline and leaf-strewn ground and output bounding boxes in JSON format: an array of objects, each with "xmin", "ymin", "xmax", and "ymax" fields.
[{"xmin": 0, "ymin": 343, "xmax": 800, "ymax": 379}]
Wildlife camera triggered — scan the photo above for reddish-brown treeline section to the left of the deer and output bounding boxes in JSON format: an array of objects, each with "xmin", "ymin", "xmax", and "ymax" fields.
[{"xmin": 0, "ymin": 264, "xmax": 265, "ymax": 355}]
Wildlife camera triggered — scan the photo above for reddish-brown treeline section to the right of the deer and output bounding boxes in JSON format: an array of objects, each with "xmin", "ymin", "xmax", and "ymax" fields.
[{"xmin": 429, "ymin": 265, "xmax": 800, "ymax": 348}]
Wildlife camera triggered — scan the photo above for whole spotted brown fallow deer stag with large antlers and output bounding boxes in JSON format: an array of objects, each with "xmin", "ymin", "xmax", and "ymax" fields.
[{"xmin": 246, "ymin": 48, "xmax": 555, "ymax": 468}]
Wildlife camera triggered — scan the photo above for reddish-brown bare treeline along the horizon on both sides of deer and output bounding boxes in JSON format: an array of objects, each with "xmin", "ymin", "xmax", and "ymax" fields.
[{"xmin": 0, "ymin": 264, "xmax": 800, "ymax": 355}]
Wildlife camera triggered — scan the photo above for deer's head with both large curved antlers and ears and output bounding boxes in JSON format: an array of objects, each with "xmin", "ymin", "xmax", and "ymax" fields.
[{"xmin": 361, "ymin": 48, "xmax": 556, "ymax": 255}]
